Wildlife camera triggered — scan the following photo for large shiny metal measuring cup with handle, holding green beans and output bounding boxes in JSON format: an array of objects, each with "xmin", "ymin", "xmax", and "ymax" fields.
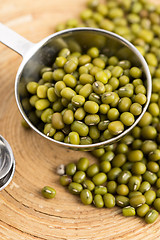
[{"xmin": 0, "ymin": 23, "xmax": 152, "ymax": 151}]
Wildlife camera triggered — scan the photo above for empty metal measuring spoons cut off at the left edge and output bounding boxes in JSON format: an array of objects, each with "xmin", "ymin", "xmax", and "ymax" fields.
[{"xmin": 0, "ymin": 136, "xmax": 15, "ymax": 190}]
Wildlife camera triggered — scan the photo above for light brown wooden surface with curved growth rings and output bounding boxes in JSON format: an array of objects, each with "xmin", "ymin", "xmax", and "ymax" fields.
[{"xmin": 0, "ymin": 0, "xmax": 160, "ymax": 240}]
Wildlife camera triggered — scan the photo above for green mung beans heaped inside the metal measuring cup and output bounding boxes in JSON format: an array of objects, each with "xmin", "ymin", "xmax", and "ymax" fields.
[{"xmin": 27, "ymin": 47, "xmax": 146, "ymax": 145}]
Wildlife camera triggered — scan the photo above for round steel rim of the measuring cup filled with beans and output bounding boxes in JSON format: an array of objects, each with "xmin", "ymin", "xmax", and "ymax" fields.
[{"xmin": 15, "ymin": 27, "xmax": 152, "ymax": 151}]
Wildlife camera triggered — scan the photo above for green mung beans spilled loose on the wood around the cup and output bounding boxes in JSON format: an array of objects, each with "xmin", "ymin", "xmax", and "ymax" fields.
[{"xmin": 56, "ymin": 0, "xmax": 160, "ymax": 223}]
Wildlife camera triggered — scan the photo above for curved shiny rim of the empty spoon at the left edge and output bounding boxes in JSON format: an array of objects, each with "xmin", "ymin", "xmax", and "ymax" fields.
[{"xmin": 0, "ymin": 135, "xmax": 15, "ymax": 191}]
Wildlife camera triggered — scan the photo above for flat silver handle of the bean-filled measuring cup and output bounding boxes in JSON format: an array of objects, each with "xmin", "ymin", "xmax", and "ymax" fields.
[{"xmin": 0, "ymin": 23, "xmax": 34, "ymax": 56}]
